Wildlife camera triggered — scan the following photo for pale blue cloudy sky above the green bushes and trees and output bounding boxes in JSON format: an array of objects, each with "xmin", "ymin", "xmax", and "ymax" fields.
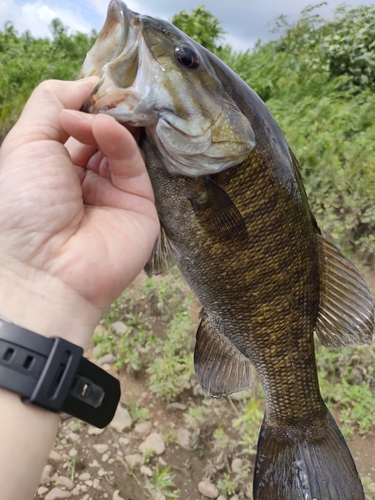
[{"xmin": 0, "ymin": 0, "xmax": 375, "ymax": 51}]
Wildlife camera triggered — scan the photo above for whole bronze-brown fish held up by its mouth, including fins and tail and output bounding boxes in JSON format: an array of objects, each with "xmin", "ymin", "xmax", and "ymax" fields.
[{"xmin": 81, "ymin": 0, "xmax": 374, "ymax": 500}]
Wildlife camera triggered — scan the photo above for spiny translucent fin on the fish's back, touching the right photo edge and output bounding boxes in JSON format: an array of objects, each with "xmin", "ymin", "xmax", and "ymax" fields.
[{"xmin": 315, "ymin": 237, "xmax": 374, "ymax": 349}]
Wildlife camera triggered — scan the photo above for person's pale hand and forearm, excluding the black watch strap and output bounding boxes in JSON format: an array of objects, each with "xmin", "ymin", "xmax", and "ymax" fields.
[{"xmin": 0, "ymin": 78, "xmax": 159, "ymax": 500}]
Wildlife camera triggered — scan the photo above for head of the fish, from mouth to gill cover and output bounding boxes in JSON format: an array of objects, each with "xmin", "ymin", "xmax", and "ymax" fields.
[{"xmin": 80, "ymin": 0, "xmax": 255, "ymax": 177}]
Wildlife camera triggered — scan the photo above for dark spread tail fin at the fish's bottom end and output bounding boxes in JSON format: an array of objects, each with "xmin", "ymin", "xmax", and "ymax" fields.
[{"xmin": 253, "ymin": 410, "xmax": 365, "ymax": 500}]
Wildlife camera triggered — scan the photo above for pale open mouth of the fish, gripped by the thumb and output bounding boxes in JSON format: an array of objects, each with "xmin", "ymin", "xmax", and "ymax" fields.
[{"xmin": 79, "ymin": 0, "xmax": 159, "ymax": 127}]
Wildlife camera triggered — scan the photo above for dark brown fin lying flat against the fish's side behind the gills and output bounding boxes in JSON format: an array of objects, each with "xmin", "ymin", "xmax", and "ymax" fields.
[{"xmin": 189, "ymin": 177, "xmax": 248, "ymax": 241}]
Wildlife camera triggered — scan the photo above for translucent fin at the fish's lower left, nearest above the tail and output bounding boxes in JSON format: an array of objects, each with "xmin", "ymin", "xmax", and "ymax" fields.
[{"xmin": 194, "ymin": 309, "xmax": 254, "ymax": 398}]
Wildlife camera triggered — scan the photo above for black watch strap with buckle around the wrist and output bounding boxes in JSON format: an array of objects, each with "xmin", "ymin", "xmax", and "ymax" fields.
[{"xmin": 0, "ymin": 319, "xmax": 121, "ymax": 428}]
